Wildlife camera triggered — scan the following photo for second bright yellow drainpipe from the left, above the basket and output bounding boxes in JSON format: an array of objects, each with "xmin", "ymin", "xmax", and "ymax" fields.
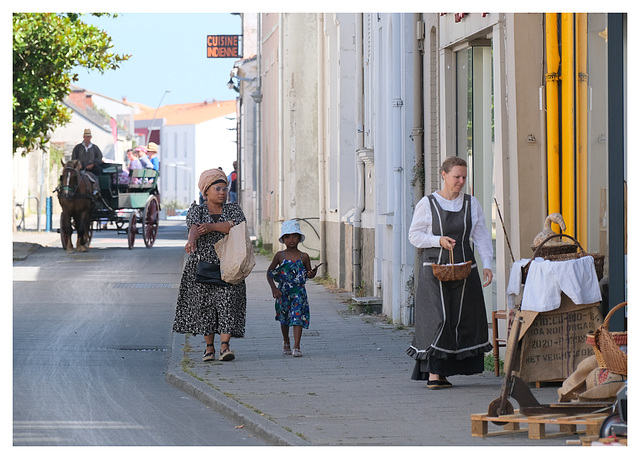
[{"xmin": 560, "ymin": 13, "xmax": 576, "ymax": 237}]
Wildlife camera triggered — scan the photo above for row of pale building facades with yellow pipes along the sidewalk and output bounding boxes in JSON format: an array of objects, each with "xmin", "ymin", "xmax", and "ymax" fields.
[{"xmin": 232, "ymin": 13, "xmax": 626, "ymax": 324}]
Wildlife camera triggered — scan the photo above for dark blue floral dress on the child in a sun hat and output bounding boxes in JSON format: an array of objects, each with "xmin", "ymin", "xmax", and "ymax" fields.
[{"xmin": 269, "ymin": 260, "xmax": 309, "ymax": 328}]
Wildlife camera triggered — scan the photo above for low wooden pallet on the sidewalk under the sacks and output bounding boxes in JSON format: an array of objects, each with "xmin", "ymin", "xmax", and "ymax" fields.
[{"xmin": 471, "ymin": 410, "xmax": 607, "ymax": 440}]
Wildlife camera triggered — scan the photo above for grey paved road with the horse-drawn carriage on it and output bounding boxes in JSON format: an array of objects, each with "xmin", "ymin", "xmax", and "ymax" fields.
[{"xmin": 13, "ymin": 222, "xmax": 266, "ymax": 446}]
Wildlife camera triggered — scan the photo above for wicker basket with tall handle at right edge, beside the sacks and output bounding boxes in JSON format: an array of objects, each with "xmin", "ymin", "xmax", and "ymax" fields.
[{"xmin": 587, "ymin": 301, "xmax": 627, "ymax": 375}]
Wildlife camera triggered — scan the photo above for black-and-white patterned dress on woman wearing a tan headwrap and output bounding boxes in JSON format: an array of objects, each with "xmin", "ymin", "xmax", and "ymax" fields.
[{"xmin": 173, "ymin": 202, "xmax": 247, "ymax": 338}]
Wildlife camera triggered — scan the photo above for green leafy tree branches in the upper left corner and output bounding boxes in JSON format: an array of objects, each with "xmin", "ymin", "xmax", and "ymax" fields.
[{"xmin": 13, "ymin": 13, "xmax": 131, "ymax": 155}]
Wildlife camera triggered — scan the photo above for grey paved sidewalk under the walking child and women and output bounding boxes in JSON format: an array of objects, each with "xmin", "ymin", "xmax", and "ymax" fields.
[{"xmin": 167, "ymin": 256, "xmax": 578, "ymax": 446}]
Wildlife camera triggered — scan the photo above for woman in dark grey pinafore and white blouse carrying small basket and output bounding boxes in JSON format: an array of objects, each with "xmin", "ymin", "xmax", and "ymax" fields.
[{"xmin": 407, "ymin": 156, "xmax": 493, "ymax": 389}]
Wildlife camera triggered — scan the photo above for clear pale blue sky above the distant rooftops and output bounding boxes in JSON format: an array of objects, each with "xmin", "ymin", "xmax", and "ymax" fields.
[{"xmin": 75, "ymin": 12, "xmax": 242, "ymax": 107}]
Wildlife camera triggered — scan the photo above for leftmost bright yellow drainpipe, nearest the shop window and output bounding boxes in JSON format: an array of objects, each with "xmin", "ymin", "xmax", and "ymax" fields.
[{"xmin": 545, "ymin": 13, "xmax": 560, "ymax": 233}]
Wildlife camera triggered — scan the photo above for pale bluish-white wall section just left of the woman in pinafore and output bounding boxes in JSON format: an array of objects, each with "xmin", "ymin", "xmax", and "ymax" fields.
[{"xmin": 363, "ymin": 13, "xmax": 415, "ymax": 323}]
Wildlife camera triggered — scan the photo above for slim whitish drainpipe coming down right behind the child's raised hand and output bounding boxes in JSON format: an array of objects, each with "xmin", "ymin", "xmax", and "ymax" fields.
[{"xmin": 317, "ymin": 13, "xmax": 329, "ymax": 275}]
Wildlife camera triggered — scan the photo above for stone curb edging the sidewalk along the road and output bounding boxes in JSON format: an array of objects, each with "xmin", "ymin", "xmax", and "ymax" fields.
[{"xmin": 166, "ymin": 333, "xmax": 311, "ymax": 446}]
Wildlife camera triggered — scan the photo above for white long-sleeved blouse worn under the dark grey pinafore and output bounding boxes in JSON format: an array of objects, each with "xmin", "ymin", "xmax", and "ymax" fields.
[{"xmin": 409, "ymin": 192, "xmax": 493, "ymax": 269}]
